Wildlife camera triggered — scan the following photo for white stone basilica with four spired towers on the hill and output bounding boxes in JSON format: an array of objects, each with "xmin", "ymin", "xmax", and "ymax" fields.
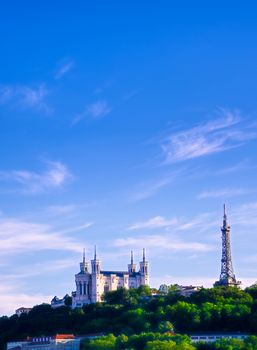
[{"xmin": 72, "ymin": 250, "xmax": 149, "ymax": 308}]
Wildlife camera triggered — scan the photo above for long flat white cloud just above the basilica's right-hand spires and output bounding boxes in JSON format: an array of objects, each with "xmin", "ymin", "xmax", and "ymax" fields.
[{"xmin": 114, "ymin": 235, "xmax": 213, "ymax": 252}]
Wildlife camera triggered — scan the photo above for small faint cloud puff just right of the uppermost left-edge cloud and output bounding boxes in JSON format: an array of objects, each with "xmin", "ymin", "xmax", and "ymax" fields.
[{"xmin": 72, "ymin": 100, "xmax": 112, "ymax": 125}]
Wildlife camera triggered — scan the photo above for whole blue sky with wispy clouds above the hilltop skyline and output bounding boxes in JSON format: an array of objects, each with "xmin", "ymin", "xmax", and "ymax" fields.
[{"xmin": 0, "ymin": 1, "xmax": 257, "ymax": 314}]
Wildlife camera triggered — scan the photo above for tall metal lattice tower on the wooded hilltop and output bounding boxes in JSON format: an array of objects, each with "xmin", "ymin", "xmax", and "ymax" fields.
[{"xmin": 215, "ymin": 204, "xmax": 241, "ymax": 286}]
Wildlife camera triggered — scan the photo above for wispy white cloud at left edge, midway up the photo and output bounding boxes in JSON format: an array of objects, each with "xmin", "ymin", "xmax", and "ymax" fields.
[{"xmin": 0, "ymin": 161, "xmax": 72, "ymax": 194}]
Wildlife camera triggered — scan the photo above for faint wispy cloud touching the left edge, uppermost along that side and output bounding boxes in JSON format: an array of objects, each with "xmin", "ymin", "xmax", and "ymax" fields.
[{"xmin": 0, "ymin": 84, "xmax": 53, "ymax": 114}]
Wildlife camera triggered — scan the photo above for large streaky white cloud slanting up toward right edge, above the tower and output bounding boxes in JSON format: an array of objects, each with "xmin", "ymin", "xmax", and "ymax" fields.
[{"xmin": 162, "ymin": 109, "xmax": 257, "ymax": 163}]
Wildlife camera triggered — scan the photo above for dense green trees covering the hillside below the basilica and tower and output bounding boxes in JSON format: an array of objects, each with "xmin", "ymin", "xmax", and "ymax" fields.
[{"xmin": 0, "ymin": 286, "xmax": 257, "ymax": 350}]
